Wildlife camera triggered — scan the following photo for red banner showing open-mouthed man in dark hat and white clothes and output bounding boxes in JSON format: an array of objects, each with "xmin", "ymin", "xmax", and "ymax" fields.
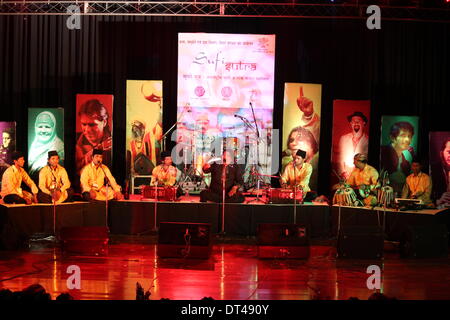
[{"xmin": 331, "ymin": 100, "xmax": 370, "ymax": 186}]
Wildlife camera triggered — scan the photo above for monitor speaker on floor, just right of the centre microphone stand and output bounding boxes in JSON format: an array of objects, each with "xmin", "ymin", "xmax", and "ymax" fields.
[{"xmin": 257, "ymin": 223, "xmax": 310, "ymax": 259}]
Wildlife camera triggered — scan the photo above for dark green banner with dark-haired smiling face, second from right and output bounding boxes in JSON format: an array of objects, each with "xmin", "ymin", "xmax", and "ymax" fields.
[{"xmin": 380, "ymin": 116, "xmax": 420, "ymax": 197}]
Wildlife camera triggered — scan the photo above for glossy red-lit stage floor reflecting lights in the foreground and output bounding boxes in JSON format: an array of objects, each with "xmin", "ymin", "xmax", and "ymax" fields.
[{"xmin": 0, "ymin": 237, "xmax": 450, "ymax": 300}]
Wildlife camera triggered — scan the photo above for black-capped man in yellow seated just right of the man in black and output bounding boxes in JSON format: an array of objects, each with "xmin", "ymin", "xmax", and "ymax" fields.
[{"xmin": 281, "ymin": 149, "xmax": 313, "ymax": 200}]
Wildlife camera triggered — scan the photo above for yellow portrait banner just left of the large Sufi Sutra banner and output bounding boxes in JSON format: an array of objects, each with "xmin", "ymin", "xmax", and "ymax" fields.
[{"xmin": 126, "ymin": 80, "xmax": 163, "ymax": 176}]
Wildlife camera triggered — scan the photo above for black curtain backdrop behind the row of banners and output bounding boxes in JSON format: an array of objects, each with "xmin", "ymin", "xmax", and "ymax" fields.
[{"xmin": 0, "ymin": 16, "xmax": 450, "ymax": 198}]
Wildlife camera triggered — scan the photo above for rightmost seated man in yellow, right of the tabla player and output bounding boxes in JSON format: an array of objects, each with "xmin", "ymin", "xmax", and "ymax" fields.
[{"xmin": 402, "ymin": 160, "xmax": 431, "ymax": 204}]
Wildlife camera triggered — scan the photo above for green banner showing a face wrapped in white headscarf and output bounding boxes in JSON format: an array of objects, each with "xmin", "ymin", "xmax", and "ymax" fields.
[{"xmin": 27, "ymin": 108, "xmax": 64, "ymax": 181}]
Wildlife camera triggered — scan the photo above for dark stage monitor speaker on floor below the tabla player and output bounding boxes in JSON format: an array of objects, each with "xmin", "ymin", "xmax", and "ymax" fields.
[{"xmin": 337, "ymin": 226, "xmax": 384, "ymax": 260}]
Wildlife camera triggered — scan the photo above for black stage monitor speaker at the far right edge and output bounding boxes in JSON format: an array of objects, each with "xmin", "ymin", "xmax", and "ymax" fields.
[{"xmin": 400, "ymin": 224, "xmax": 449, "ymax": 258}]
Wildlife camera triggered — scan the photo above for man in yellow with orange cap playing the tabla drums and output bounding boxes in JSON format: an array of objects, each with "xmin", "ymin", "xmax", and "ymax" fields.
[{"xmin": 347, "ymin": 153, "xmax": 379, "ymax": 206}]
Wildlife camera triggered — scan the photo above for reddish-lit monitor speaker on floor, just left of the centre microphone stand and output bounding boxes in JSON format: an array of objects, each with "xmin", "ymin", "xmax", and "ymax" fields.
[{"xmin": 158, "ymin": 222, "xmax": 212, "ymax": 259}]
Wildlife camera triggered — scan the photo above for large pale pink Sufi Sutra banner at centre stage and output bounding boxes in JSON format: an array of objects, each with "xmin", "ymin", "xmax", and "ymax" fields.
[{"xmin": 177, "ymin": 33, "xmax": 275, "ymax": 187}]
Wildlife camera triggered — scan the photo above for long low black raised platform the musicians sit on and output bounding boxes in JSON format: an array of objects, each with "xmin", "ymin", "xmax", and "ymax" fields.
[{"xmin": 0, "ymin": 196, "xmax": 450, "ymax": 249}]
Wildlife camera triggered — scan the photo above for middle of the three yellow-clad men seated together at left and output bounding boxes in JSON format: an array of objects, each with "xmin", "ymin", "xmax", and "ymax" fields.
[{"xmin": 37, "ymin": 150, "xmax": 73, "ymax": 203}]
